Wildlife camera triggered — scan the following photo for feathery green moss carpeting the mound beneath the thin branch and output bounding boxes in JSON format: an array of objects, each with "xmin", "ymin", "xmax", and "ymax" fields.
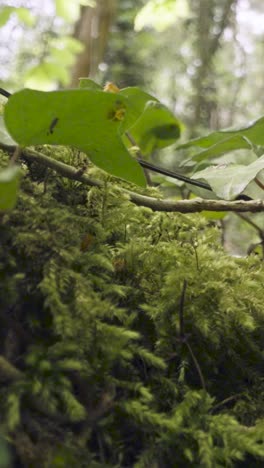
[{"xmin": 0, "ymin": 149, "xmax": 264, "ymax": 468}]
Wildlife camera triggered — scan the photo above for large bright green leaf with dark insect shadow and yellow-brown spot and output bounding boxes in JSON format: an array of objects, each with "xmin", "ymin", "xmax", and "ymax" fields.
[{"xmin": 4, "ymin": 89, "xmax": 145, "ymax": 186}]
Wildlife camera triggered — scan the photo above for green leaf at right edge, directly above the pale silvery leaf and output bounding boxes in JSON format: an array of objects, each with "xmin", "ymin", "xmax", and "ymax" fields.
[{"xmin": 178, "ymin": 117, "xmax": 264, "ymax": 152}]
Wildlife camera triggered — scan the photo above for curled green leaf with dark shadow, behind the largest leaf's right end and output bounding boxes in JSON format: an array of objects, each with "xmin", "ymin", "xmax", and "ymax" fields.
[{"xmin": 128, "ymin": 101, "xmax": 181, "ymax": 154}]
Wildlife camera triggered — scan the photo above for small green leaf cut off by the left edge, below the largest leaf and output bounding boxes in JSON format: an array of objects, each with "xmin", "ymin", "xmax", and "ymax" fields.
[{"xmin": 0, "ymin": 166, "xmax": 20, "ymax": 211}]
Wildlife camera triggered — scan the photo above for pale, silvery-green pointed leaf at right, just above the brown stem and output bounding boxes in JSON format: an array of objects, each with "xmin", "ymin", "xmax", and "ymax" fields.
[{"xmin": 192, "ymin": 156, "xmax": 264, "ymax": 200}]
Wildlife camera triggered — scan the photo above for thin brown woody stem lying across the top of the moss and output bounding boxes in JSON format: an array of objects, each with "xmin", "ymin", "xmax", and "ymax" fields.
[{"xmin": 0, "ymin": 143, "xmax": 264, "ymax": 213}]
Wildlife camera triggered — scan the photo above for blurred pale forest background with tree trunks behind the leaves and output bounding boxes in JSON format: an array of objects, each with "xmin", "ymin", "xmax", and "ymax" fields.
[{"xmin": 0, "ymin": 0, "xmax": 264, "ymax": 255}]
